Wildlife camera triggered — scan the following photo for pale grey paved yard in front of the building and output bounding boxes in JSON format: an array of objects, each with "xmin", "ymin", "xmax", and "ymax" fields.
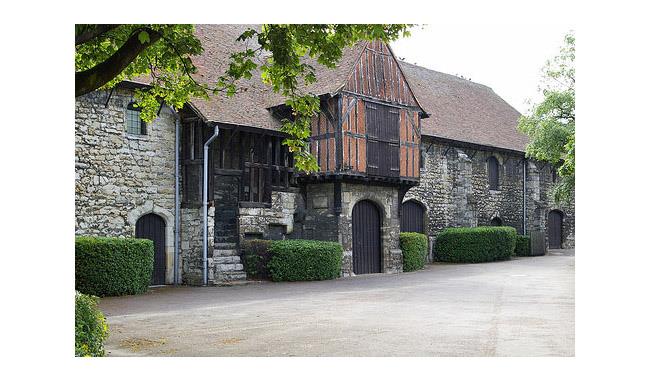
[{"xmin": 100, "ymin": 251, "xmax": 575, "ymax": 356}]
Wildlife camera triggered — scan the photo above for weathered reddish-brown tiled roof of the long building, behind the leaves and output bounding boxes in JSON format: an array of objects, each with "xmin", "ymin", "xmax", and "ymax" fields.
[{"xmin": 137, "ymin": 25, "xmax": 527, "ymax": 152}]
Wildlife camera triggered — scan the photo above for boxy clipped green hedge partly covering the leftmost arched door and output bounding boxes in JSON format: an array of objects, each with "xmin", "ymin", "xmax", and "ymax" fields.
[{"xmin": 75, "ymin": 236, "xmax": 153, "ymax": 297}]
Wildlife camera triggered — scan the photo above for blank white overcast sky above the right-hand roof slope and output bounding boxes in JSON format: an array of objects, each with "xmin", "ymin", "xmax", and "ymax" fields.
[{"xmin": 391, "ymin": 23, "xmax": 575, "ymax": 113}]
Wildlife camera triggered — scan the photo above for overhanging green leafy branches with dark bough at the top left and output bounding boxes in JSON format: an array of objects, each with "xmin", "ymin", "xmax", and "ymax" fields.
[{"xmin": 75, "ymin": 24, "xmax": 411, "ymax": 172}]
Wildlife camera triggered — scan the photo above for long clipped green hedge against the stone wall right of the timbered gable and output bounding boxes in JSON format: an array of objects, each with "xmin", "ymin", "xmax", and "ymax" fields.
[{"xmin": 435, "ymin": 227, "xmax": 517, "ymax": 263}]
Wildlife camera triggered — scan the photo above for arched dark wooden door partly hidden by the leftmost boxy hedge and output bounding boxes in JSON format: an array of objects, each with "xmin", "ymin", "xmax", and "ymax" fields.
[{"xmin": 135, "ymin": 214, "xmax": 167, "ymax": 285}]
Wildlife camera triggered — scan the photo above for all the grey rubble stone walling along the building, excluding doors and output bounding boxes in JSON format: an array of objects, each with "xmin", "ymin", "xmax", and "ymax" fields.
[{"xmin": 75, "ymin": 89, "xmax": 575, "ymax": 284}]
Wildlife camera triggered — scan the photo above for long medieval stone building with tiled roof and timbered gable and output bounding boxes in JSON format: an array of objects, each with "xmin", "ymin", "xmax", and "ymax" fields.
[{"xmin": 75, "ymin": 25, "xmax": 574, "ymax": 284}]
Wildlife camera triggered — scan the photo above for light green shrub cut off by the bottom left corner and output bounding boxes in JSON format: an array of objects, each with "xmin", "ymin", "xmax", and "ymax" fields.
[{"xmin": 74, "ymin": 292, "xmax": 108, "ymax": 356}]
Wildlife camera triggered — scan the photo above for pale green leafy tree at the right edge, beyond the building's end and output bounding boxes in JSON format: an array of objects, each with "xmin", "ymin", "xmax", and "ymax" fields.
[{"xmin": 518, "ymin": 33, "xmax": 576, "ymax": 203}]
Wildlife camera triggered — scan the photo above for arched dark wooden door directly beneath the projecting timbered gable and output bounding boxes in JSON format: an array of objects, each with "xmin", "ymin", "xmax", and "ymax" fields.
[{"xmin": 352, "ymin": 201, "xmax": 381, "ymax": 274}]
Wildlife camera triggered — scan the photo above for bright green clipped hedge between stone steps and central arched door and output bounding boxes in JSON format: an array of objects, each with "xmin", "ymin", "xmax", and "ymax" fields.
[{"xmin": 268, "ymin": 240, "xmax": 343, "ymax": 281}]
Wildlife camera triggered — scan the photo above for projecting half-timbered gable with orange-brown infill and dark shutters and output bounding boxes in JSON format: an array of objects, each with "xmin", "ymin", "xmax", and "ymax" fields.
[{"xmin": 294, "ymin": 41, "xmax": 426, "ymax": 182}]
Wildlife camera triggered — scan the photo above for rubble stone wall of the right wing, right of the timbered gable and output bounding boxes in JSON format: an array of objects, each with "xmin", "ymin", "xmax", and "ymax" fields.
[{"xmin": 404, "ymin": 138, "xmax": 575, "ymax": 252}]
